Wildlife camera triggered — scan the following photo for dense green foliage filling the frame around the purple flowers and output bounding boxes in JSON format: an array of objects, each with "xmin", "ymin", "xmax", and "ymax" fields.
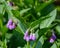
[{"xmin": 0, "ymin": 0, "xmax": 60, "ymax": 48}]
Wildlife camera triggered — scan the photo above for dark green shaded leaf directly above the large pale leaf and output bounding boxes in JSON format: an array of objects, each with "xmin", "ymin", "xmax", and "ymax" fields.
[{"xmin": 41, "ymin": 4, "xmax": 54, "ymax": 16}]
